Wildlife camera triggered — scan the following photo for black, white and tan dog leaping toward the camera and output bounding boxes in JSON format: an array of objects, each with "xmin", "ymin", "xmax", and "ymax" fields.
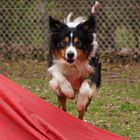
[{"xmin": 48, "ymin": 13, "xmax": 101, "ymax": 119}]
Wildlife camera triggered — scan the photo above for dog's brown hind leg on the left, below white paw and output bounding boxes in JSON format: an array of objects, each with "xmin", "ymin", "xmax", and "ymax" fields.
[{"xmin": 57, "ymin": 93, "xmax": 67, "ymax": 112}]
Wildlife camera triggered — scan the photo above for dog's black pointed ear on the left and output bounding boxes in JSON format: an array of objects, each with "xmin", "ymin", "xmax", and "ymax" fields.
[{"xmin": 49, "ymin": 16, "xmax": 65, "ymax": 32}]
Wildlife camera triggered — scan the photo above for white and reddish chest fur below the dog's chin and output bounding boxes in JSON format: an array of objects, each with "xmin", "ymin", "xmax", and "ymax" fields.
[{"xmin": 48, "ymin": 61, "xmax": 93, "ymax": 89}]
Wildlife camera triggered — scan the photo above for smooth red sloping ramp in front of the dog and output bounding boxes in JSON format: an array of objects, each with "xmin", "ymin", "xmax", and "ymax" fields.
[{"xmin": 0, "ymin": 75, "xmax": 127, "ymax": 140}]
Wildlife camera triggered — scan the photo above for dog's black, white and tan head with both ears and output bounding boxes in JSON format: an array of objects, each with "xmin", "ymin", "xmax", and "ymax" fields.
[{"xmin": 49, "ymin": 14, "xmax": 95, "ymax": 63}]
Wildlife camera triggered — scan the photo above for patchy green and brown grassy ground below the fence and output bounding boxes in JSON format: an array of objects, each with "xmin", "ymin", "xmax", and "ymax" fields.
[{"xmin": 0, "ymin": 61, "xmax": 140, "ymax": 140}]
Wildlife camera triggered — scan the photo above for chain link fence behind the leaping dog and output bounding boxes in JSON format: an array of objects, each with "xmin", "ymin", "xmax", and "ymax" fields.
[{"xmin": 0, "ymin": 0, "xmax": 140, "ymax": 62}]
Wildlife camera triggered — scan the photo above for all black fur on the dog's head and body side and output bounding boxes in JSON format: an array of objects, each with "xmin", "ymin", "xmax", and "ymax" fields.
[{"xmin": 48, "ymin": 15, "xmax": 101, "ymax": 87}]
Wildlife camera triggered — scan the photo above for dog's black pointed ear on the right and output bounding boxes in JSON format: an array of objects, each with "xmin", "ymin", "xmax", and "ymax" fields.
[{"xmin": 78, "ymin": 15, "xmax": 96, "ymax": 33}]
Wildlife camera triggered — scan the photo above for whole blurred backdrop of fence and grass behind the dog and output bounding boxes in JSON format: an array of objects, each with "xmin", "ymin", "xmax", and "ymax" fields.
[{"xmin": 0, "ymin": 0, "xmax": 140, "ymax": 140}]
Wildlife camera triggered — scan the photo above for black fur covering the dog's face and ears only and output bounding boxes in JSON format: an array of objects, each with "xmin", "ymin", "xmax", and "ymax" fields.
[{"xmin": 49, "ymin": 16, "xmax": 96, "ymax": 54}]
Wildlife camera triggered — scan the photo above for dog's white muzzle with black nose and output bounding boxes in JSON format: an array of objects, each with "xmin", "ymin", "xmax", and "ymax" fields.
[{"xmin": 65, "ymin": 46, "xmax": 77, "ymax": 63}]
